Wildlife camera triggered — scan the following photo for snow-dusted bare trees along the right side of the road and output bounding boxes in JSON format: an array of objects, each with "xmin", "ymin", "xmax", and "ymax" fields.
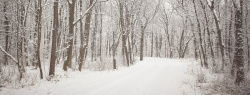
[{"xmin": 173, "ymin": 0, "xmax": 250, "ymax": 84}]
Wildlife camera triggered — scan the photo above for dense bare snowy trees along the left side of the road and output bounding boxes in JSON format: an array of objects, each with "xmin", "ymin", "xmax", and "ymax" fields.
[{"xmin": 0, "ymin": 0, "xmax": 166, "ymax": 80}]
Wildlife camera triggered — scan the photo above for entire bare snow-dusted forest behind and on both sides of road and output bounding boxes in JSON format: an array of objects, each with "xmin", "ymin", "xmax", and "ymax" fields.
[{"xmin": 0, "ymin": 0, "xmax": 250, "ymax": 89}]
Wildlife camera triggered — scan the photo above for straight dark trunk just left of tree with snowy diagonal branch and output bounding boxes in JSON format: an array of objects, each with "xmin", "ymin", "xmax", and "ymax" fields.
[{"xmin": 49, "ymin": 0, "xmax": 59, "ymax": 76}]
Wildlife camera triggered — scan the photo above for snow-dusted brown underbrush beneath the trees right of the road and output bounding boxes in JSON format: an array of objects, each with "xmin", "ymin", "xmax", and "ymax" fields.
[{"xmin": 190, "ymin": 60, "xmax": 250, "ymax": 95}]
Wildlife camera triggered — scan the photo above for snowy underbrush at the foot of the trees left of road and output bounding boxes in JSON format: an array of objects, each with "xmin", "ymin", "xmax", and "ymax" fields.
[{"xmin": 0, "ymin": 58, "xmax": 138, "ymax": 90}]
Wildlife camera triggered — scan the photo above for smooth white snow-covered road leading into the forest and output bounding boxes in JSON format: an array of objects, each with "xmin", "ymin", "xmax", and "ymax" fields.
[{"xmin": 58, "ymin": 58, "xmax": 197, "ymax": 95}]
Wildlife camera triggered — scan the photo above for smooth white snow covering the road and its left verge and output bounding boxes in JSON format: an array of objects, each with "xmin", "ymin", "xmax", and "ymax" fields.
[{"xmin": 0, "ymin": 58, "xmax": 198, "ymax": 95}]
